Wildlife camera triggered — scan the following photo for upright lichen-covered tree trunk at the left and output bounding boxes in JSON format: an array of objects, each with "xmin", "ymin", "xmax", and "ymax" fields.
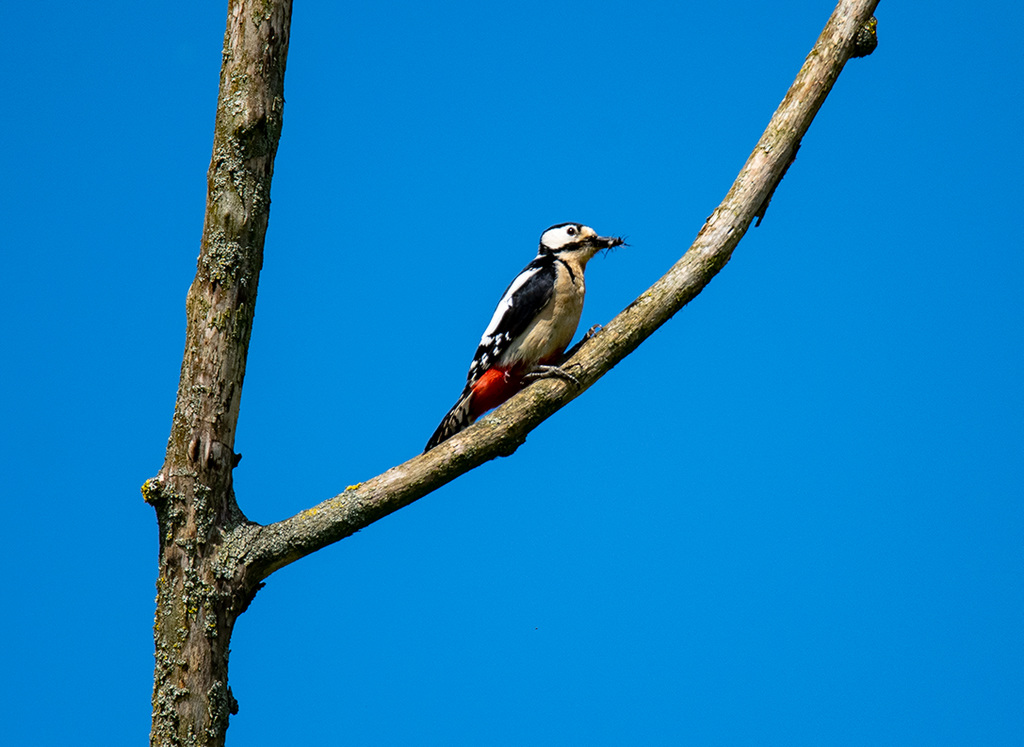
[{"xmin": 143, "ymin": 0, "xmax": 292, "ymax": 745}]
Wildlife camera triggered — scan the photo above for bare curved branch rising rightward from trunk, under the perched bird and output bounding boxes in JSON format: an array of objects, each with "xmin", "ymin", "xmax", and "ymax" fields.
[{"xmin": 234, "ymin": 0, "xmax": 878, "ymax": 584}]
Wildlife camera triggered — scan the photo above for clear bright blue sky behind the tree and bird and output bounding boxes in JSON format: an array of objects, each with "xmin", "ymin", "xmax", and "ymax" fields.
[{"xmin": 0, "ymin": 0, "xmax": 1024, "ymax": 745}]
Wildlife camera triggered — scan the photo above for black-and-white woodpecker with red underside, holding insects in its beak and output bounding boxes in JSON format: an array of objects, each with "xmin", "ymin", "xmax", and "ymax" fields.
[{"xmin": 424, "ymin": 223, "xmax": 623, "ymax": 452}]
